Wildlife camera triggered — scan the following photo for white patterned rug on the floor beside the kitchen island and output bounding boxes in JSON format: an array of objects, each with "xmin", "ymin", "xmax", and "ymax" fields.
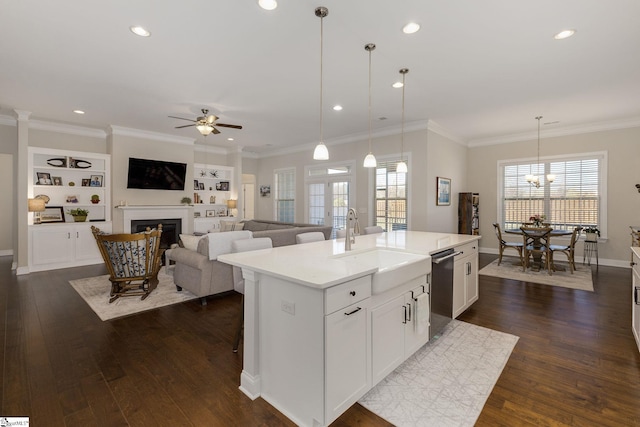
[{"xmin": 358, "ymin": 320, "xmax": 518, "ymax": 427}]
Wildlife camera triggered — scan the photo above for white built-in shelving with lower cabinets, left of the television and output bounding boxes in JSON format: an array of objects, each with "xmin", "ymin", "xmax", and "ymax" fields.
[{"xmin": 28, "ymin": 147, "xmax": 112, "ymax": 271}]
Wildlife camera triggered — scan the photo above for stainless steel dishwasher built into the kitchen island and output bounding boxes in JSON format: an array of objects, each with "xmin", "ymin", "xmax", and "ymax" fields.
[{"xmin": 429, "ymin": 249, "xmax": 462, "ymax": 340}]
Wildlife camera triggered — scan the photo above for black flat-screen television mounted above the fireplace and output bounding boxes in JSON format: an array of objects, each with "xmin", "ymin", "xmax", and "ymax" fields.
[{"xmin": 127, "ymin": 157, "xmax": 187, "ymax": 191}]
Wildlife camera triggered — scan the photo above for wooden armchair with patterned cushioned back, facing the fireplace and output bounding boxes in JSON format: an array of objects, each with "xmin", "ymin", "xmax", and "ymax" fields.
[{"xmin": 91, "ymin": 224, "xmax": 164, "ymax": 303}]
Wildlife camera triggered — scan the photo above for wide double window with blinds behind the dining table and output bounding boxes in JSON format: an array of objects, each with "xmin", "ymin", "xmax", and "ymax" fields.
[{"xmin": 498, "ymin": 152, "xmax": 607, "ymax": 237}]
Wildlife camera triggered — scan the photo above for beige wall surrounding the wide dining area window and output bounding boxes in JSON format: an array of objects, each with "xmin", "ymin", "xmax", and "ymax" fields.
[{"xmin": 468, "ymin": 128, "xmax": 640, "ymax": 267}]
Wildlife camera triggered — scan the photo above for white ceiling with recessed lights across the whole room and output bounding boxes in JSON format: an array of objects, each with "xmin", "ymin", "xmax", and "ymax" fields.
[{"xmin": 0, "ymin": 0, "xmax": 640, "ymax": 152}]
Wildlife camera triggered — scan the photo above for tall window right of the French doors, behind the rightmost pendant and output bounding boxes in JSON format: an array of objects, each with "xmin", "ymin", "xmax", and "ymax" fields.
[{"xmin": 374, "ymin": 159, "xmax": 407, "ymax": 231}]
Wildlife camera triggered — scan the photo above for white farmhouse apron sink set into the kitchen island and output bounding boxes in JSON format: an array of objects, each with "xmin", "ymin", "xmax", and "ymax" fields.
[{"xmin": 334, "ymin": 248, "xmax": 431, "ymax": 294}]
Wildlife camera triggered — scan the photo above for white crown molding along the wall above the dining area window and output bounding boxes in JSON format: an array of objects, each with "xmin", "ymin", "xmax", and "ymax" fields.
[{"xmin": 469, "ymin": 117, "xmax": 640, "ymax": 147}]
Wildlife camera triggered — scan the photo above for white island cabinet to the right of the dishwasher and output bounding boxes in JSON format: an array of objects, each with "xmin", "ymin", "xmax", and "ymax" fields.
[{"xmin": 452, "ymin": 241, "xmax": 478, "ymax": 318}]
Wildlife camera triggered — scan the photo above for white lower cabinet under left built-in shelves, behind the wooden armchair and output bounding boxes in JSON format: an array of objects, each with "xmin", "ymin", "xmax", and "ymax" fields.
[{"xmin": 29, "ymin": 222, "xmax": 111, "ymax": 271}]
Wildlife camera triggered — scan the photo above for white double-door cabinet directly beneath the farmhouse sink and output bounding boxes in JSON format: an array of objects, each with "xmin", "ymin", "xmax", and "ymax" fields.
[{"xmin": 371, "ymin": 276, "xmax": 429, "ymax": 386}]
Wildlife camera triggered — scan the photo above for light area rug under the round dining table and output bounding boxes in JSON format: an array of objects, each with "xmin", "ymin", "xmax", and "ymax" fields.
[{"xmin": 478, "ymin": 257, "xmax": 593, "ymax": 292}]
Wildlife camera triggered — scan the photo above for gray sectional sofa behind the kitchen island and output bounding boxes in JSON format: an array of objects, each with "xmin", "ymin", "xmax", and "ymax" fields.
[{"xmin": 166, "ymin": 220, "xmax": 332, "ymax": 305}]
